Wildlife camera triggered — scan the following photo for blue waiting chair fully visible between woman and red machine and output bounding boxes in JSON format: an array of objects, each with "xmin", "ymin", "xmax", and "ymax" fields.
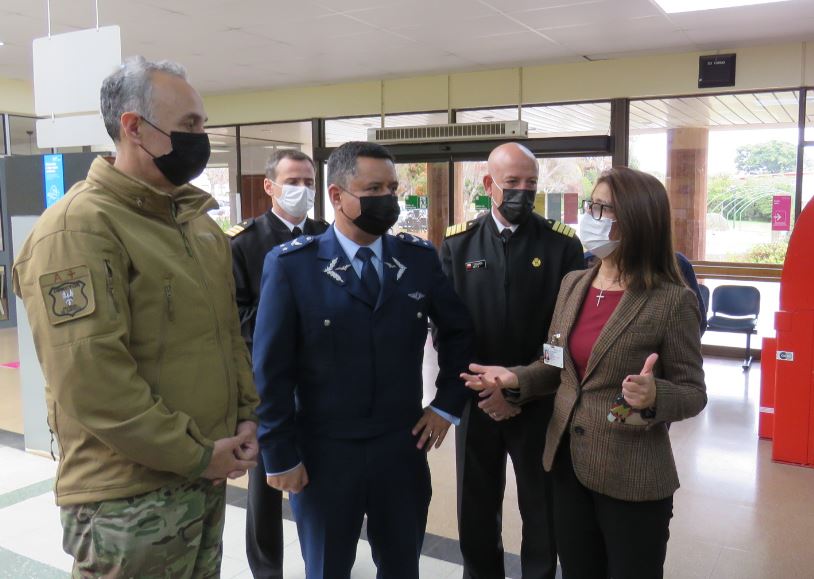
[{"xmin": 707, "ymin": 285, "xmax": 760, "ymax": 371}]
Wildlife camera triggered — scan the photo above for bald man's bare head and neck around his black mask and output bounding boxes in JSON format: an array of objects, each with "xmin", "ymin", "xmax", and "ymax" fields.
[{"xmin": 483, "ymin": 143, "xmax": 540, "ymax": 224}]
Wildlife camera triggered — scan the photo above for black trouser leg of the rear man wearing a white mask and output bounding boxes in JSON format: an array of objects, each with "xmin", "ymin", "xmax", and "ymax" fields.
[{"xmin": 246, "ymin": 453, "xmax": 283, "ymax": 579}]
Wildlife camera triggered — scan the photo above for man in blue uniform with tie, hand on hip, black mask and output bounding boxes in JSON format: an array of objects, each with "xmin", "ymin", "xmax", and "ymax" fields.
[{"xmin": 253, "ymin": 142, "xmax": 472, "ymax": 579}]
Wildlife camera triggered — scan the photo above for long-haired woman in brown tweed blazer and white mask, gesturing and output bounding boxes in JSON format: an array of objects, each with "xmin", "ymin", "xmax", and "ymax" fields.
[{"xmin": 462, "ymin": 168, "xmax": 707, "ymax": 579}]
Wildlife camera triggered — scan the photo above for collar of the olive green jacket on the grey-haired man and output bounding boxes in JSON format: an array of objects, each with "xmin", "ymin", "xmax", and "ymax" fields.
[{"xmin": 86, "ymin": 157, "xmax": 218, "ymax": 223}]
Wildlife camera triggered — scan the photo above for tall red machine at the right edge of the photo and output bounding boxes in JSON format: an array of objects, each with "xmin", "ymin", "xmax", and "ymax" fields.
[{"xmin": 772, "ymin": 197, "xmax": 814, "ymax": 467}]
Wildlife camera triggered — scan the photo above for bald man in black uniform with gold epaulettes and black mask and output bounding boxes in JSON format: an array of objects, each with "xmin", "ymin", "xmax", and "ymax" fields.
[{"xmin": 441, "ymin": 143, "xmax": 583, "ymax": 579}]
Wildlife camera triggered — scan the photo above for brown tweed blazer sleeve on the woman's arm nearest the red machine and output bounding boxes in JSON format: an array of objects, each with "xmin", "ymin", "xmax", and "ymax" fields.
[{"xmin": 654, "ymin": 288, "xmax": 707, "ymax": 422}]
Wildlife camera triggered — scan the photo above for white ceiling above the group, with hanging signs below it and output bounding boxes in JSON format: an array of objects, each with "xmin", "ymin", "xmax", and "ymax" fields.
[{"xmin": 0, "ymin": 0, "xmax": 814, "ymax": 92}]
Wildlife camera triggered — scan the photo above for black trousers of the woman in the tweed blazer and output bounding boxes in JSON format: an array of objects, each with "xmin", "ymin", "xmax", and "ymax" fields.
[{"xmin": 552, "ymin": 437, "xmax": 673, "ymax": 579}]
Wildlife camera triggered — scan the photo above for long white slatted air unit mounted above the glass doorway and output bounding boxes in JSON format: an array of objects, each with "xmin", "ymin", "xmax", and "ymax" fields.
[{"xmin": 367, "ymin": 121, "xmax": 529, "ymax": 144}]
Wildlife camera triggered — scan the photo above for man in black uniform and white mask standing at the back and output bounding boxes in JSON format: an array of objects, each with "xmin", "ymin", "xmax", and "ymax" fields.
[{"xmin": 226, "ymin": 149, "xmax": 328, "ymax": 579}]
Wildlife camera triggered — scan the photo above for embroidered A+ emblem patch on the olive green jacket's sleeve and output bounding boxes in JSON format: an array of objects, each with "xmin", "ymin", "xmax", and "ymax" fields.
[{"xmin": 40, "ymin": 265, "xmax": 96, "ymax": 326}]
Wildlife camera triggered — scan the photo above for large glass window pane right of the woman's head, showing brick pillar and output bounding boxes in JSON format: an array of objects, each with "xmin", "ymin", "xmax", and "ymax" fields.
[{"xmin": 630, "ymin": 91, "xmax": 798, "ymax": 263}]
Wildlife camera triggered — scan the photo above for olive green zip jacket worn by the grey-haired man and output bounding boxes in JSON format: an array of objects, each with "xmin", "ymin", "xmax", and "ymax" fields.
[{"xmin": 14, "ymin": 158, "xmax": 258, "ymax": 505}]
